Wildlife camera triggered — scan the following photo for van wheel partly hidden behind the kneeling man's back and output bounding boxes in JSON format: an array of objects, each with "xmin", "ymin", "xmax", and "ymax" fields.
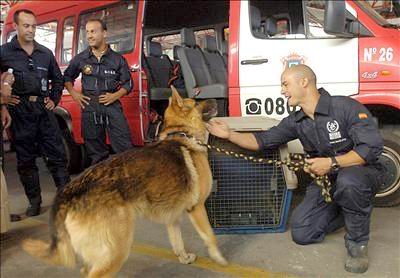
[{"xmin": 374, "ymin": 126, "xmax": 400, "ymax": 207}]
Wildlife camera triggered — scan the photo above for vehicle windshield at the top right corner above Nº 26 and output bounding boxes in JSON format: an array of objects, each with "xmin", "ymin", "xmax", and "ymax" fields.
[{"xmin": 355, "ymin": 0, "xmax": 400, "ymax": 29}]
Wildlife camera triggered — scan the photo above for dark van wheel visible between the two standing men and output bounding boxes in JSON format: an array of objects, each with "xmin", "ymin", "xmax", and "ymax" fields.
[{"xmin": 62, "ymin": 130, "xmax": 84, "ymax": 174}]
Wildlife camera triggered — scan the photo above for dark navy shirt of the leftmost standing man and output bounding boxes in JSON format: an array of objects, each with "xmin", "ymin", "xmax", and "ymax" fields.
[{"xmin": 0, "ymin": 36, "xmax": 64, "ymax": 105}]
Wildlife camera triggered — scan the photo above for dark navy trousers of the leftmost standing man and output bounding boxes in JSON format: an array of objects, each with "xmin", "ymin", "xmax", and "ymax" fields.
[{"xmin": 10, "ymin": 99, "xmax": 70, "ymax": 205}]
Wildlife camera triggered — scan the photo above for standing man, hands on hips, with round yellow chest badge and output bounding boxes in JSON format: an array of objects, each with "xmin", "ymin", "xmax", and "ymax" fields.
[{"xmin": 64, "ymin": 19, "xmax": 132, "ymax": 164}]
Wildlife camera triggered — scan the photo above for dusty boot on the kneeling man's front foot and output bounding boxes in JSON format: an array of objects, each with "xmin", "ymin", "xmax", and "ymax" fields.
[{"xmin": 344, "ymin": 245, "xmax": 368, "ymax": 273}]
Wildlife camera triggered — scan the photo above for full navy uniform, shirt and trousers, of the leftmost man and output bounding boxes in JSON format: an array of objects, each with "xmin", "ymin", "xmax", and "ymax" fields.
[{"xmin": 0, "ymin": 36, "xmax": 70, "ymax": 206}]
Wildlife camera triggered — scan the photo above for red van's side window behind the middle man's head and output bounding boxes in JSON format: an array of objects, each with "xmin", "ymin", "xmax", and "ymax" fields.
[{"xmin": 77, "ymin": 1, "xmax": 137, "ymax": 54}]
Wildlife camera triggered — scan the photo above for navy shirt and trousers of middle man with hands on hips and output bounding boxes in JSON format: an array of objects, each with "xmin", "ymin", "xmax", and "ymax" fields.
[{"xmin": 64, "ymin": 47, "xmax": 132, "ymax": 164}]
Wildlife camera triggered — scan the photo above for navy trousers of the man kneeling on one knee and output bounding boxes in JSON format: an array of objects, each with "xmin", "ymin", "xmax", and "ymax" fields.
[{"xmin": 291, "ymin": 166, "xmax": 383, "ymax": 245}]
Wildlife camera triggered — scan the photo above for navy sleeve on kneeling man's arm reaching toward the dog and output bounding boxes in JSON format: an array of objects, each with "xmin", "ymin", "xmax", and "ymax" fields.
[{"xmin": 253, "ymin": 115, "xmax": 298, "ymax": 150}]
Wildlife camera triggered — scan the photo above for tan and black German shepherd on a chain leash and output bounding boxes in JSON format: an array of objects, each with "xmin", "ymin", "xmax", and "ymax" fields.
[{"xmin": 23, "ymin": 88, "xmax": 227, "ymax": 277}]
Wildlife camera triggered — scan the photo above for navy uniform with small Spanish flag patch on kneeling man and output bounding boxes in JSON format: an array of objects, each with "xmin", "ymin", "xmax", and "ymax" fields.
[{"xmin": 255, "ymin": 89, "xmax": 383, "ymax": 248}]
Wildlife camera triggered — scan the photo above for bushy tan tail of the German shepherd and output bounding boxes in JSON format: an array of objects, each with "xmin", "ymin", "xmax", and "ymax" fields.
[{"xmin": 22, "ymin": 197, "xmax": 76, "ymax": 268}]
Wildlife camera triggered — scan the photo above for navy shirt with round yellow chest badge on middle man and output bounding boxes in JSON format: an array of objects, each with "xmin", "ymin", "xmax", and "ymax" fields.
[{"xmin": 64, "ymin": 47, "xmax": 132, "ymax": 95}]
